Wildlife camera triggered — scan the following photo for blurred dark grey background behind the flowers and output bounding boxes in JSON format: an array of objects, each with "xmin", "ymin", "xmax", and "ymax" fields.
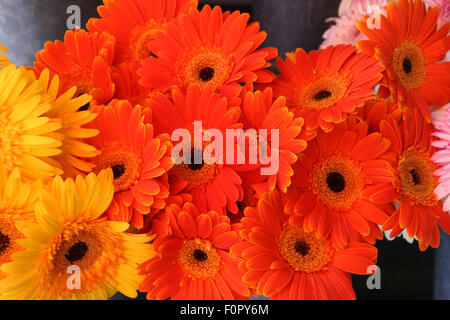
[{"xmin": 0, "ymin": 0, "xmax": 450, "ymax": 300}]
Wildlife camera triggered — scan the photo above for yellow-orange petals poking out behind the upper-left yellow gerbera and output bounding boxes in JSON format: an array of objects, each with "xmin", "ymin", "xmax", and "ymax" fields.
[{"xmin": 39, "ymin": 69, "xmax": 100, "ymax": 178}]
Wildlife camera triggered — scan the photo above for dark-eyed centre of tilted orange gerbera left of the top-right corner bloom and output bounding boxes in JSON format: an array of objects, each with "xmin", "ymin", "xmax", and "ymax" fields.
[{"xmin": 297, "ymin": 73, "xmax": 350, "ymax": 110}]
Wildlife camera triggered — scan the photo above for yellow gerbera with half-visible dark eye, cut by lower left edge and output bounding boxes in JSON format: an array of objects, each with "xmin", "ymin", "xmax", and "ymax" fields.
[{"xmin": 0, "ymin": 164, "xmax": 42, "ymax": 282}]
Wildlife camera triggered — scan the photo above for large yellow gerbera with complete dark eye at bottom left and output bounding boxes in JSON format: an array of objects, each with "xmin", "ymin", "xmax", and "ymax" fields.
[{"xmin": 0, "ymin": 169, "xmax": 155, "ymax": 300}]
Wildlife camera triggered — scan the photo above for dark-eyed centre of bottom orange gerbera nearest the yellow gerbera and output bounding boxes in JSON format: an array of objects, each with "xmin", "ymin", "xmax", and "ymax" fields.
[{"xmin": 178, "ymin": 238, "xmax": 222, "ymax": 280}]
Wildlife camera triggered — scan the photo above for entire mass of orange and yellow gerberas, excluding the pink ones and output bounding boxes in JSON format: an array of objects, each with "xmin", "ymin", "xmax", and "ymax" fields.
[{"xmin": 0, "ymin": 0, "xmax": 450, "ymax": 300}]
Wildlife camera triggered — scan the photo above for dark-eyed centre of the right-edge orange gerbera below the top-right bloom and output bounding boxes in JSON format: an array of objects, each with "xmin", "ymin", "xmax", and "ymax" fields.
[{"xmin": 395, "ymin": 147, "xmax": 437, "ymax": 206}]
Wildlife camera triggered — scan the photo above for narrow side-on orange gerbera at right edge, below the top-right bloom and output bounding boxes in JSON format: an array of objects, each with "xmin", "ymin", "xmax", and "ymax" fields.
[{"xmin": 380, "ymin": 109, "xmax": 450, "ymax": 251}]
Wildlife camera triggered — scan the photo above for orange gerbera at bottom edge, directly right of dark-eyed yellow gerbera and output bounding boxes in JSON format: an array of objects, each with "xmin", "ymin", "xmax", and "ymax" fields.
[{"xmin": 139, "ymin": 203, "xmax": 250, "ymax": 300}]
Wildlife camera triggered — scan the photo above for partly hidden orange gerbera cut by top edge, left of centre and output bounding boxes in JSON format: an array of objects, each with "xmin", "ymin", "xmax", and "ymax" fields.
[{"xmin": 87, "ymin": 0, "xmax": 198, "ymax": 65}]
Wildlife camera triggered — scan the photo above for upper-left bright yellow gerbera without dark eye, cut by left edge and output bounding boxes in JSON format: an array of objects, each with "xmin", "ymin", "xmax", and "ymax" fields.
[{"xmin": 0, "ymin": 65, "xmax": 63, "ymax": 179}]
